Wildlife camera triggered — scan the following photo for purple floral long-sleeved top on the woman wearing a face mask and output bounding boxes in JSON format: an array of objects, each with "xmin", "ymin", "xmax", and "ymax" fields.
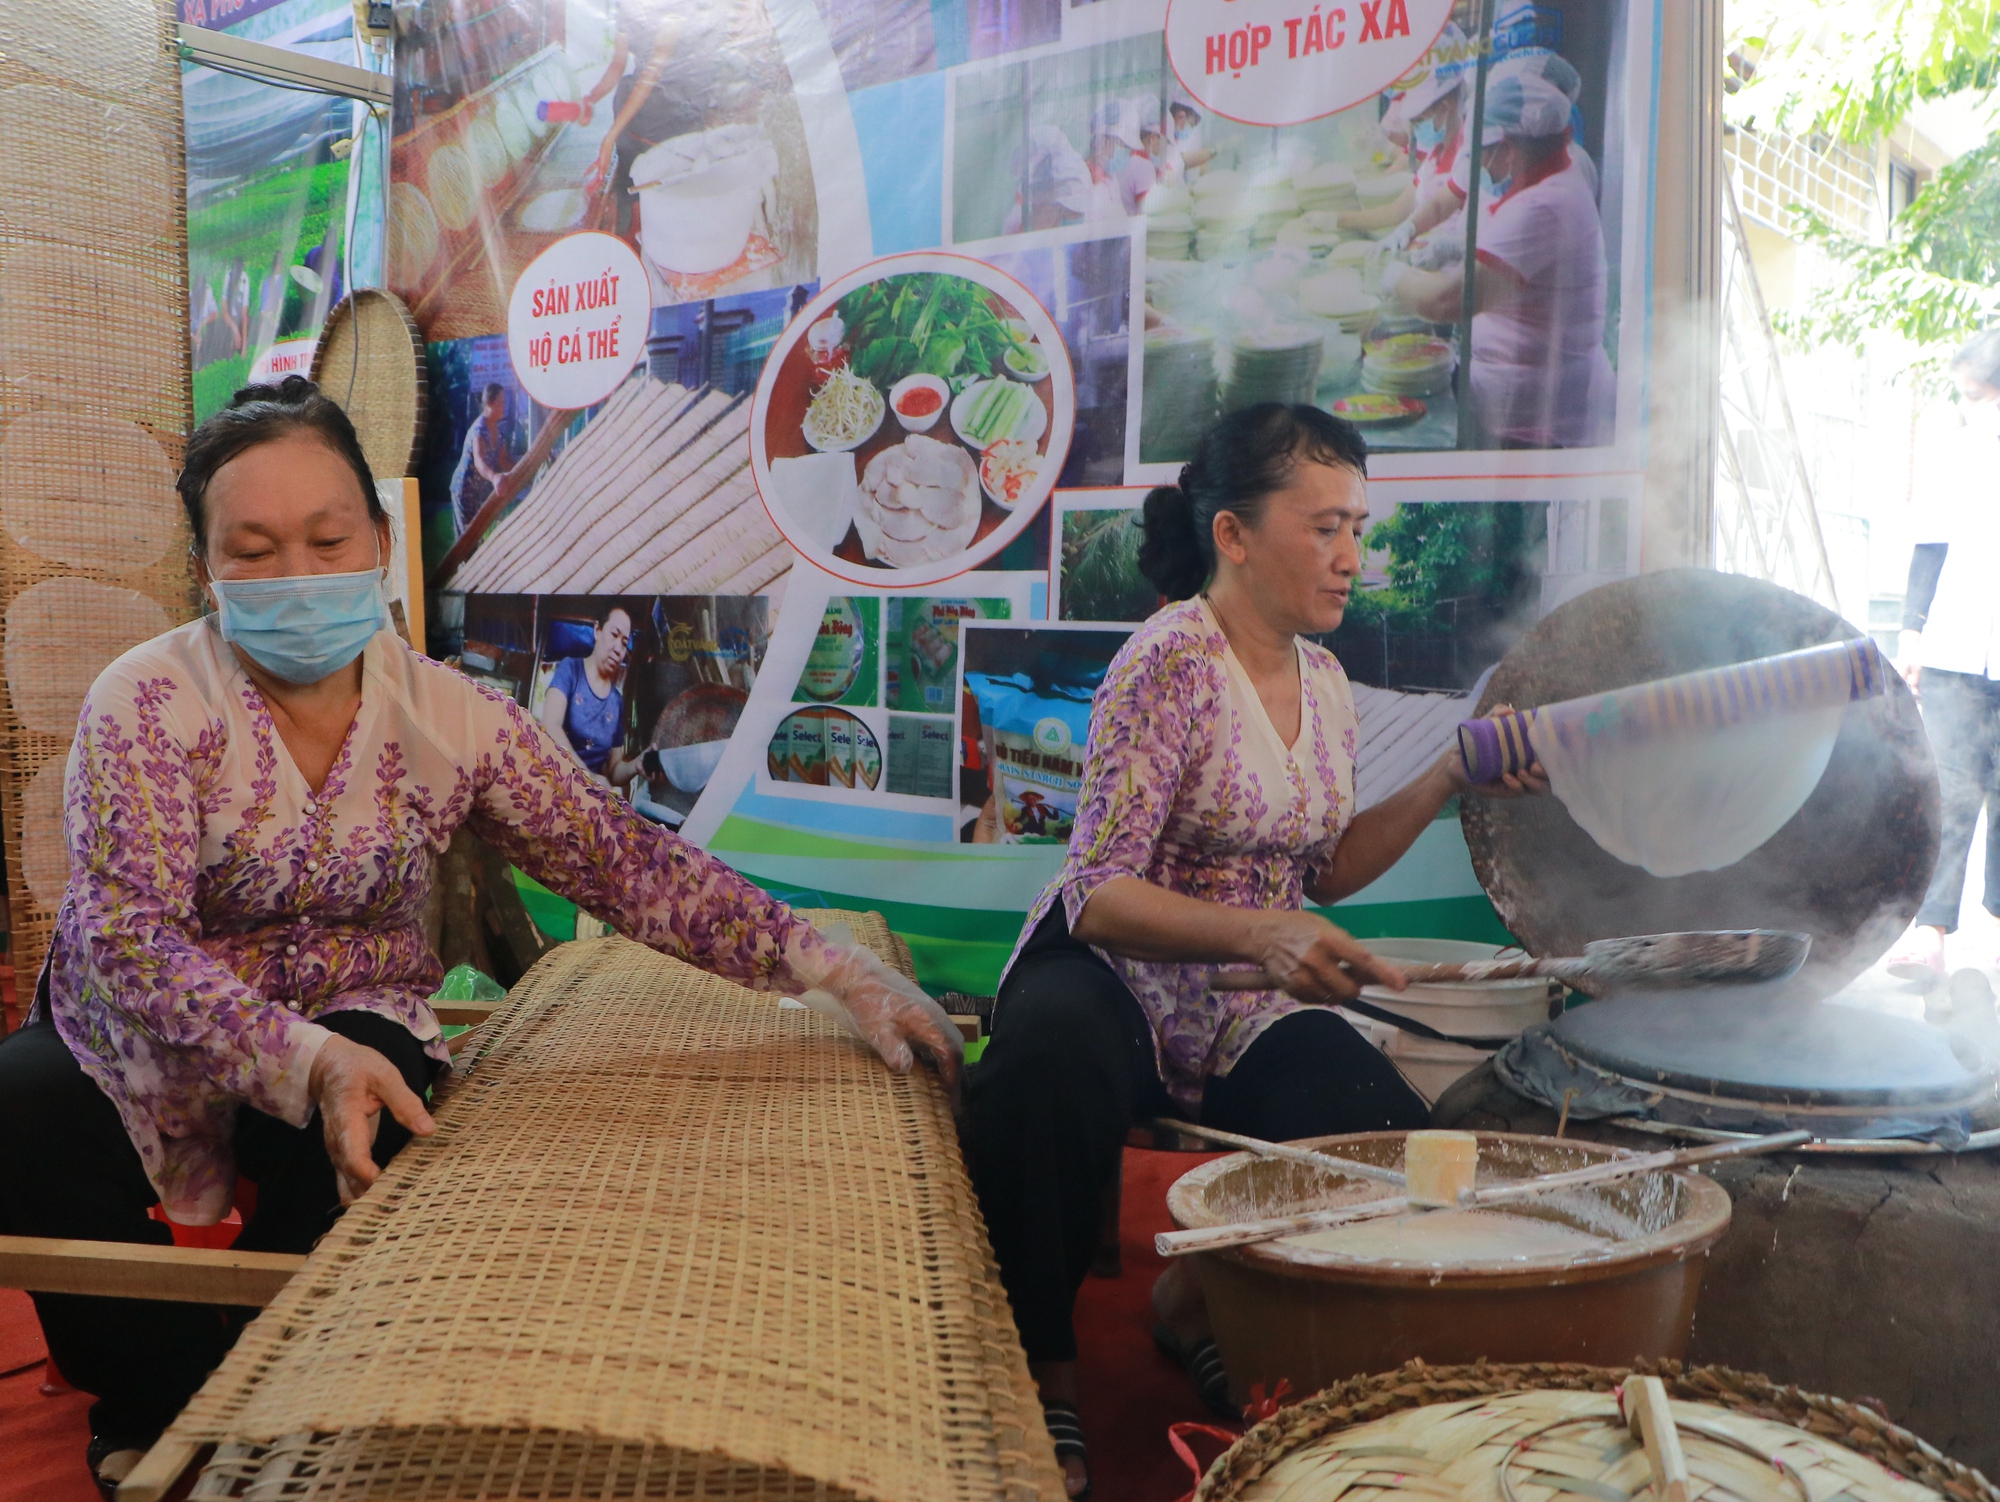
[{"xmin": 48, "ymin": 620, "xmax": 842, "ymax": 1226}]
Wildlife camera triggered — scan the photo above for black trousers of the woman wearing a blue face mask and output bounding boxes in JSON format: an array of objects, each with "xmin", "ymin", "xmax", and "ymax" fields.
[{"xmin": 0, "ymin": 1006, "xmax": 438, "ymax": 1446}]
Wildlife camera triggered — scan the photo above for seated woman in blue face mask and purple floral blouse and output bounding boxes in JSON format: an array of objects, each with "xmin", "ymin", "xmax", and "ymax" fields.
[{"xmin": 0, "ymin": 376, "xmax": 958, "ymax": 1488}]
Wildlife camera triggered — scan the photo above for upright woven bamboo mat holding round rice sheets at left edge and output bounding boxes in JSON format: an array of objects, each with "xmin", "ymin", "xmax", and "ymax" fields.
[{"xmin": 0, "ymin": 0, "xmax": 194, "ymax": 976}]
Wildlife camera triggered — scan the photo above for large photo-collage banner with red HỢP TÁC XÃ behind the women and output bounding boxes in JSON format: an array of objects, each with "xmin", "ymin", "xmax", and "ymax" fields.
[{"xmin": 406, "ymin": 0, "xmax": 1656, "ymax": 992}]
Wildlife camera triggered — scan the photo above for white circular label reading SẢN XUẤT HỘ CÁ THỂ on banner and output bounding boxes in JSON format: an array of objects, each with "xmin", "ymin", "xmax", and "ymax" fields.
[{"xmin": 506, "ymin": 230, "xmax": 652, "ymax": 408}]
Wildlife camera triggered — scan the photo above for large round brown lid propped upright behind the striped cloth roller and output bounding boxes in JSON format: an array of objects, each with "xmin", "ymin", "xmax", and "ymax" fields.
[{"xmin": 1460, "ymin": 568, "xmax": 1938, "ymax": 996}]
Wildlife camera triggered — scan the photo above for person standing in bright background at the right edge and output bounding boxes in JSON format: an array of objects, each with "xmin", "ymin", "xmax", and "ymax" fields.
[{"xmin": 1888, "ymin": 328, "xmax": 2000, "ymax": 984}]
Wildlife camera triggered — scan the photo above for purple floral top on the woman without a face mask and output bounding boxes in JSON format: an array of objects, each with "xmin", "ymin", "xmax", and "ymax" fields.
[{"xmin": 1016, "ymin": 598, "xmax": 1356, "ymax": 1110}]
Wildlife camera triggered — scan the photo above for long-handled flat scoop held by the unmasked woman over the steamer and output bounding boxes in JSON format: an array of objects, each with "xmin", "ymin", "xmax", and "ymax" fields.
[{"xmin": 1208, "ymin": 928, "xmax": 1812, "ymax": 996}]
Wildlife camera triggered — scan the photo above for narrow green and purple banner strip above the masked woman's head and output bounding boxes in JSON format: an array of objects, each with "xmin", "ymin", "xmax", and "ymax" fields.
[{"xmin": 180, "ymin": 0, "xmax": 382, "ymax": 422}]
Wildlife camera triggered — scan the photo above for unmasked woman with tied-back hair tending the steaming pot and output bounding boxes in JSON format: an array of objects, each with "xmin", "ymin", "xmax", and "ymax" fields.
[{"xmin": 968, "ymin": 404, "xmax": 1542, "ymax": 1496}]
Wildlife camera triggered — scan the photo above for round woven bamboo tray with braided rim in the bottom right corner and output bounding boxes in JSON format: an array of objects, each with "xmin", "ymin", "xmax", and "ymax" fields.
[{"xmin": 1194, "ymin": 1362, "xmax": 2000, "ymax": 1502}]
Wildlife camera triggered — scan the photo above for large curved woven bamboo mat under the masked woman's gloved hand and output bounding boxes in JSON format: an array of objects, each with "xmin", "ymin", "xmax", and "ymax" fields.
[{"xmin": 168, "ymin": 914, "xmax": 1062, "ymax": 1502}]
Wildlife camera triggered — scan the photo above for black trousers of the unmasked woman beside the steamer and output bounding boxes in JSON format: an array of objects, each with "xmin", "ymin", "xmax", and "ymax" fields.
[{"xmin": 966, "ymin": 904, "xmax": 1430, "ymax": 1362}]
